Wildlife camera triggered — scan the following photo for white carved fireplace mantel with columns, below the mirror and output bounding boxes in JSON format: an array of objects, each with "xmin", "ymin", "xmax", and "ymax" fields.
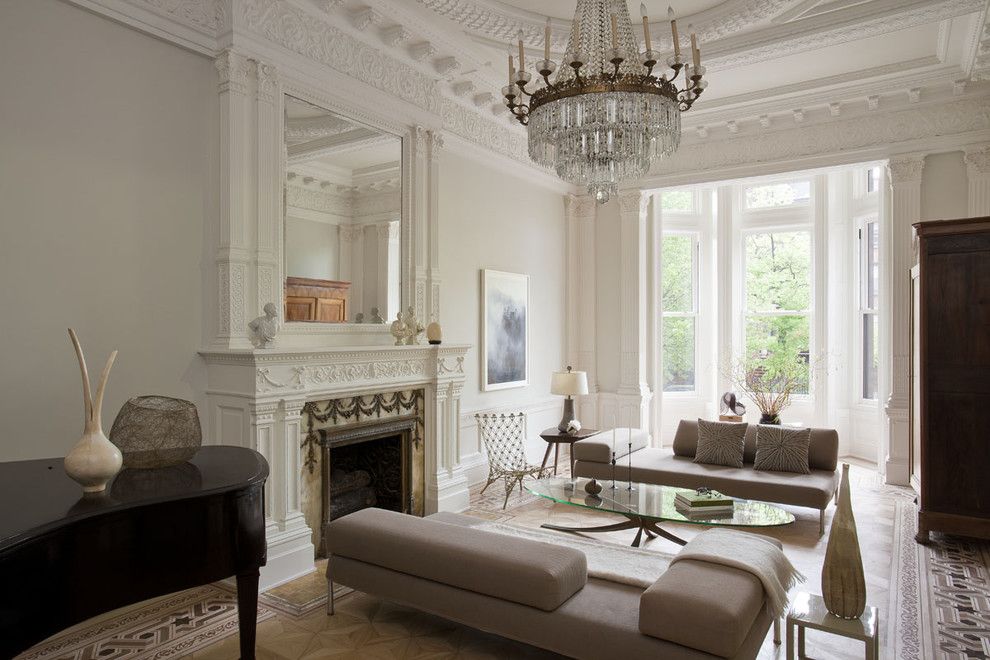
[{"xmin": 200, "ymin": 344, "xmax": 470, "ymax": 589}]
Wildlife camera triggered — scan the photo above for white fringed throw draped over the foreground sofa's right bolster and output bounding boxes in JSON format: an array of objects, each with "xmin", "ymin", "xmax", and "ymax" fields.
[{"xmin": 670, "ymin": 528, "xmax": 805, "ymax": 619}]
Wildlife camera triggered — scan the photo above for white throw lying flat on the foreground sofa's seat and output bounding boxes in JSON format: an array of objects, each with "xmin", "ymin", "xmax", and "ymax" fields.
[{"xmin": 475, "ymin": 522, "xmax": 671, "ymax": 589}]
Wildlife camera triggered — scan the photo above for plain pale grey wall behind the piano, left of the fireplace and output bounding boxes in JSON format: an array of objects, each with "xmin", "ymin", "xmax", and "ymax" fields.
[{"xmin": 0, "ymin": 0, "xmax": 218, "ymax": 460}]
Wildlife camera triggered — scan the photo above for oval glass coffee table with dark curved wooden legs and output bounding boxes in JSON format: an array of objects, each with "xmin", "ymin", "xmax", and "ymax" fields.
[{"xmin": 526, "ymin": 478, "xmax": 794, "ymax": 548}]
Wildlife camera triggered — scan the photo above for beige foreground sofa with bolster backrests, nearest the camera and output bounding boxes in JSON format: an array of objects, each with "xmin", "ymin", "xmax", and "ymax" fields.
[{"xmin": 326, "ymin": 509, "xmax": 779, "ymax": 660}]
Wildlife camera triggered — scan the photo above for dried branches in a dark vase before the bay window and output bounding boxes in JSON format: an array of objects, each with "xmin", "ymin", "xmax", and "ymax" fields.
[{"xmin": 722, "ymin": 356, "xmax": 811, "ymax": 424}]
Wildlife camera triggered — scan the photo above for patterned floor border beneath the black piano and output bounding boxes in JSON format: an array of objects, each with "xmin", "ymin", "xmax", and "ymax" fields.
[{"xmin": 17, "ymin": 585, "xmax": 274, "ymax": 660}]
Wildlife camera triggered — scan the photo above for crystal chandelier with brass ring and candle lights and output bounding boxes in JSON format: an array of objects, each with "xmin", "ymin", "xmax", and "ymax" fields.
[{"xmin": 502, "ymin": 0, "xmax": 708, "ymax": 204}]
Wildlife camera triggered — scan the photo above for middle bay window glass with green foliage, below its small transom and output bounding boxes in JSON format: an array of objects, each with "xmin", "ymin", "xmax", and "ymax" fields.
[{"xmin": 744, "ymin": 230, "xmax": 812, "ymax": 394}]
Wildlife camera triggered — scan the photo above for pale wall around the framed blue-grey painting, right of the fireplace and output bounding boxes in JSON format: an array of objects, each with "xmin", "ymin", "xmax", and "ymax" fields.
[{"xmin": 439, "ymin": 149, "xmax": 565, "ymax": 478}]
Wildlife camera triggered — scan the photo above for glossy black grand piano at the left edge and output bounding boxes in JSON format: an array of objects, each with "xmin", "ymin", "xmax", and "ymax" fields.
[{"xmin": 0, "ymin": 446, "xmax": 268, "ymax": 658}]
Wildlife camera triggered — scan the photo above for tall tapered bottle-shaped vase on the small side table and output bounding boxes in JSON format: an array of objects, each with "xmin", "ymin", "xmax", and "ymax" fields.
[{"xmin": 822, "ymin": 463, "xmax": 866, "ymax": 619}]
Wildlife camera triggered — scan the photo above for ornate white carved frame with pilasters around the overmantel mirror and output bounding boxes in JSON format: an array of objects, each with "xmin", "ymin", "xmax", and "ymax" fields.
[{"xmin": 207, "ymin": 50, "xmax": 443, "ymax": 349}]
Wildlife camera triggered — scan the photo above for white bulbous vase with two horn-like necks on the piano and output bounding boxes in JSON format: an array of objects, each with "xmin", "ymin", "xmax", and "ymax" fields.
[{"xmin": 65, "ymin": 328, "xmax": 123, "ymax": 493}]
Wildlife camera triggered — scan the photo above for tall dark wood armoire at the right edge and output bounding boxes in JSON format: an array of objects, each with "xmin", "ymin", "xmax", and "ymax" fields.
[{"xmin": 911, "ymin": 218, "xmax": 990, "ymax": 543}]
